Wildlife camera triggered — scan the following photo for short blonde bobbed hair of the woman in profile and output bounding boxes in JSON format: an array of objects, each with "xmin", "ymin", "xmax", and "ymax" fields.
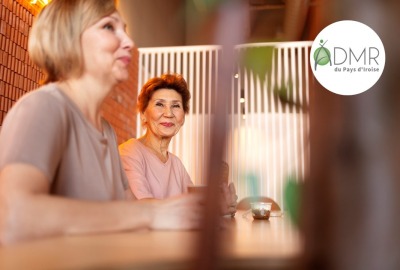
[{"xmin": 28, "ymin": 0, "xmax": 117, "ymax": 83}]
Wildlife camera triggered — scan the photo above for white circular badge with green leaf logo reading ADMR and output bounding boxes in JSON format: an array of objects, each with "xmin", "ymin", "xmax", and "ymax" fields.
[{"xmin": 310, "ymin": 21, "xmax": 386, "ymax": 96}]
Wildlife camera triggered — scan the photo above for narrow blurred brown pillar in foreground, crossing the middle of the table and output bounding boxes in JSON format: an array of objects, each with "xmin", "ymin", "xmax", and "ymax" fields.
[{"xmin": 190, "ymin": 0, "xmax": 249, "ymax": 270}]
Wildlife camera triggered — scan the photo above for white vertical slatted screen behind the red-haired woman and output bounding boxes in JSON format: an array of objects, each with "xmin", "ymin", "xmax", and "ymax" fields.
[{"xmin": 137, "ymin": 42, "xmax": 311, "ymax": 208}]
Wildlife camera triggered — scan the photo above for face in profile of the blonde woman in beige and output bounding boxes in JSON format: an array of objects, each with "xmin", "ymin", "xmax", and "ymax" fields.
[{"xmin": 81, "ymin": 12, "xmax": 133, "ymax": 84}]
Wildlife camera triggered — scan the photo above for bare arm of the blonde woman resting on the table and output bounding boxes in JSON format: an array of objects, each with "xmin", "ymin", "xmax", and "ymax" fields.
[{"xmin": 0, "ymin": 164, "xmax": 201, "ymax": 244}]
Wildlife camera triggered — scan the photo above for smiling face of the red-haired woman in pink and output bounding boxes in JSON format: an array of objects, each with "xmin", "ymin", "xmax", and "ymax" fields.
[{"xmin": 143, "ymin": 89, "xmax": 185, "ymax": 138}]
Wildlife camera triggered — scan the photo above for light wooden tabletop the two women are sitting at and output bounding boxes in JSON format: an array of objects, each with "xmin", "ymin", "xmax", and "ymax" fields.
[{"xmin": 0, "ymin": 211, "xmax": 302, "ymax": 270}]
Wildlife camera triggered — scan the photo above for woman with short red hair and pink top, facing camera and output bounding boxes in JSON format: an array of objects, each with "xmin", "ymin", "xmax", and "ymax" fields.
[{"xmin": 119, "ymin": 74, "xmax": 237, "ymax": 214}]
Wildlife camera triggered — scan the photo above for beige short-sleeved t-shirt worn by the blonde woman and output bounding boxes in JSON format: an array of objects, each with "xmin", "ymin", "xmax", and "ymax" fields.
[{"xmin": 0, "ymin": 84, "xmax": 128, "ymax": 201}]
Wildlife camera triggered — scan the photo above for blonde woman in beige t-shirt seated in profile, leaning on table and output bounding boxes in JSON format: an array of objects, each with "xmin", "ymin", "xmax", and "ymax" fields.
[{"xmin": 0, "ymin": 0, "xmax": 201, "ymax": 244}]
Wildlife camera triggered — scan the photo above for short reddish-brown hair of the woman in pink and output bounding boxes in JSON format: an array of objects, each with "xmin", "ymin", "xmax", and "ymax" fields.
[{"xmin": 137, "ymin": 73, "xmax": 190, "ymax": 113}]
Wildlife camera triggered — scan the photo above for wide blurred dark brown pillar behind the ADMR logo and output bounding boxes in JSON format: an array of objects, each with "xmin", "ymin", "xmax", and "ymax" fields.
[{"xmin": 302, "ymin": 0, "xmax": 400, "ymax": 270}]
